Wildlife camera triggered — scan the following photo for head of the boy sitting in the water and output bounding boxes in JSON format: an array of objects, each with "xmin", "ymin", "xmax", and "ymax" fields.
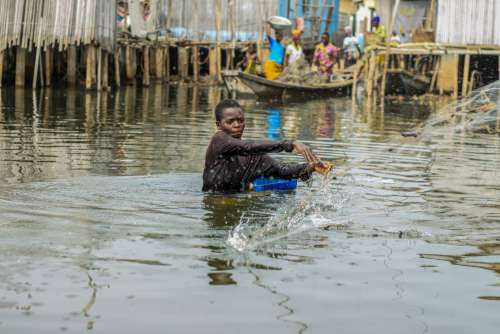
[{"xmin": 215, "ymin": 100, "xmax": 245, "ymax": 138}]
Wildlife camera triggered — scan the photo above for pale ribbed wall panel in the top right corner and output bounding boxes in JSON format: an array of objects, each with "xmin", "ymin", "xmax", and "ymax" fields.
[{"xmin": 436, "ymin": 0, "xmax": 500, "ymax": 45}]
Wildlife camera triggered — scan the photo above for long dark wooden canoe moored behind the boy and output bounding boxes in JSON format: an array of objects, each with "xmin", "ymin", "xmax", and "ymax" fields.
[{"xmin": 229, "ymin": 72, "xmax": 352, "ymax": 99}]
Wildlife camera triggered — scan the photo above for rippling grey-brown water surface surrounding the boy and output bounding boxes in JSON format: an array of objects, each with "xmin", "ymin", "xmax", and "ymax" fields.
[{"xmin": 0, "ymin": 86, "xmax": 500, "ymax": 333}]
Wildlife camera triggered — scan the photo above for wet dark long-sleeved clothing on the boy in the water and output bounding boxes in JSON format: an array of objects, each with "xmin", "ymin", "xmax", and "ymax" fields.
[{"xmin": 203, "ymin": 131, "xmax": 311, "ymax": 192}]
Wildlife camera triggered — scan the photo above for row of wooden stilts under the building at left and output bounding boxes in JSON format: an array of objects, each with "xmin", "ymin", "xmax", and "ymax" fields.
[{"xmin": 0, "ymin": 42, "xmax": 239, "ymax": 90}]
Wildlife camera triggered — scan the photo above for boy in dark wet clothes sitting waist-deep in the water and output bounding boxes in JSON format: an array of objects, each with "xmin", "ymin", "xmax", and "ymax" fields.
[{"xmin": 203, "ymin": 100, "xmax": 324, "ymax": 192}]
